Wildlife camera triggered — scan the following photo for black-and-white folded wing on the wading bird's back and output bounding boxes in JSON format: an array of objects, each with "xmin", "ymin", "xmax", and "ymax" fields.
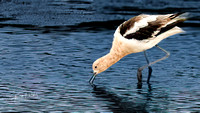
[{"xmin": 120, "ymin": 13, "xmax": 187, "ymax": 40}]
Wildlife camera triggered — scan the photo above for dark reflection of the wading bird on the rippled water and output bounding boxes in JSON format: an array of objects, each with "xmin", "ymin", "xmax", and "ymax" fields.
[{"xmin": 92, "ymin": 85, "xmax": 151, "ymax": 113}]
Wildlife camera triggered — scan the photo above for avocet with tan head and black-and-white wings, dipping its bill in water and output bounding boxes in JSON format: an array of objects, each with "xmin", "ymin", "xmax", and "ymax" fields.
[{"xmin": 89, "ymin": 13, "xmax": 188, "ymax": 85}]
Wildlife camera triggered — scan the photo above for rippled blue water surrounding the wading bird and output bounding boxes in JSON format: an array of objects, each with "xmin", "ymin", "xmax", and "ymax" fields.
[{"xmin": 0, "ymin": 0, "xmax": 200, "ymax": 112}]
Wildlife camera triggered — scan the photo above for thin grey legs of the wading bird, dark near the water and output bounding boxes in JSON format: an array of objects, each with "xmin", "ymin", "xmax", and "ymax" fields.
[{"xmin": 137, "ymin": 45, "xmax": 170, "ymax": 83}]
